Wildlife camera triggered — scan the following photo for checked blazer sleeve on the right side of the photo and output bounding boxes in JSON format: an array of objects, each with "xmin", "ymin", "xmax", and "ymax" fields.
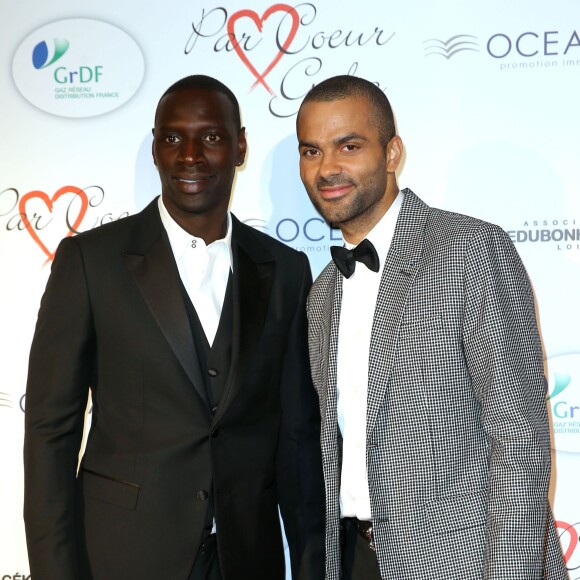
[{"xmin": 463, "ymin": 224, "xmax": 550, "ymax": 580}]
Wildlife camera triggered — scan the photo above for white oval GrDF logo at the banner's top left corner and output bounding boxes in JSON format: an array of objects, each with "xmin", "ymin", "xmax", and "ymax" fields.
[{"xmin": 12, "ymin": 18, "xmax": 145, "ymax": 118}]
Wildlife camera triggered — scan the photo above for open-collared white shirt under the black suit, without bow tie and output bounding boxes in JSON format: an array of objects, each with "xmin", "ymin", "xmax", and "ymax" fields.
[{"xmin": 158, "ymin": 196, "xmax": 232, "ymax": 346}]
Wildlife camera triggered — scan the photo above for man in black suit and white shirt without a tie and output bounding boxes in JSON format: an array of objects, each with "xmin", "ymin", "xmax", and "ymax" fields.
[{"xmin": 24, "ymin": 76, "xmax": 324, "ymax": 580}]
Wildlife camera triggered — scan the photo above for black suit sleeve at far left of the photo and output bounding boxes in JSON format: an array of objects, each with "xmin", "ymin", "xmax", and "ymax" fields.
[{"xmin": 24, "ymin": 238, "xmax": 96, "ymax": 580}]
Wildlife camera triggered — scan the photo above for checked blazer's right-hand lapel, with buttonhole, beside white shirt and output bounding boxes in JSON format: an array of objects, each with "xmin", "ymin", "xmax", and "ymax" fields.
[{"xmin": 367, "ymin": 189, "xmax": 429, "ymax": 434}]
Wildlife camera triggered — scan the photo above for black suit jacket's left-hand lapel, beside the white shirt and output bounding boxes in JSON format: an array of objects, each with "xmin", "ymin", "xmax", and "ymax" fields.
[{"xmin": 123, "ymin": 200, "xmax": 207, "ymax": 403}]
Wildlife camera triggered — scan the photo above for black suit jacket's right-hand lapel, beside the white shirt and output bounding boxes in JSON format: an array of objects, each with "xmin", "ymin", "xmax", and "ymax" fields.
[{"xmin": 214, "ymin": 215, "xmax": 274, "ymax": 422}]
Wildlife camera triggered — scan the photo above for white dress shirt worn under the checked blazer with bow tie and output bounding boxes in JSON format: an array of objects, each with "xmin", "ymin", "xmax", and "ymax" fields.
[{"xmin": 337, "ymin": 193, "xmax": 403, "ymax": 521}]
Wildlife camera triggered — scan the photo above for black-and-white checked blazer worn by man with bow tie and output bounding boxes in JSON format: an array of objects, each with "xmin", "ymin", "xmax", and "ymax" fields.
[{"xmin": 308, "ymin": 189, "xmax": 568, "ymax": 580}]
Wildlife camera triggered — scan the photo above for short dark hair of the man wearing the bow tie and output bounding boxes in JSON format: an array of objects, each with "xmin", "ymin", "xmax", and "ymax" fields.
[{"xmin": 298, "ymin": 75, "xmax": 396, "ymax": 147}]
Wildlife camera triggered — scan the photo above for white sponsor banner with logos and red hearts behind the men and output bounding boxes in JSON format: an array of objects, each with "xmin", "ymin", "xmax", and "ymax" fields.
[{"xmin": 0, "ymin": 0, "xmax": 580, "ymax": 580}]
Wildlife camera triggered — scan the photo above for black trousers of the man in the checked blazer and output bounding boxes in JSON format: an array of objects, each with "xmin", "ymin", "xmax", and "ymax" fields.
[{"xmin": 342, "ymin": 518, "xmax": 381, "ymax": 580}]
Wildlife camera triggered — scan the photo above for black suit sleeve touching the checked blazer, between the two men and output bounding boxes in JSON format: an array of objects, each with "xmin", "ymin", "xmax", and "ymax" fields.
[{"xmin": 277, "ymin": 254, "xmax": 325, "ymax": 580}]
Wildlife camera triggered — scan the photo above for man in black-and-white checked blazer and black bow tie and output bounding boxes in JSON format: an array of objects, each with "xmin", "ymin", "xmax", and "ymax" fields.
[{"xmin": 297, "ymin": 77, "xmax": 568, "ymax": 580}]
